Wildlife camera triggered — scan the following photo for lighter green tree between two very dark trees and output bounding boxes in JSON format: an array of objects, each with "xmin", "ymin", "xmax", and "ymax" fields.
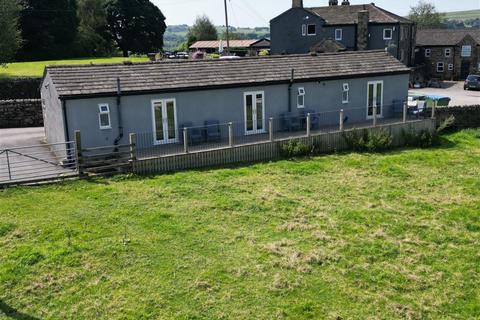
[{"xmin": 76, "ymin": 0, "xmax": 115, "ymax": 57}]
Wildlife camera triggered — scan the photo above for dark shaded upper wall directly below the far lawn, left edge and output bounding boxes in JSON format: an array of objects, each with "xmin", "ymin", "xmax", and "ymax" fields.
[{"xmin": 0, "ymin": 78, "xmax": 42, "ymax": 100}]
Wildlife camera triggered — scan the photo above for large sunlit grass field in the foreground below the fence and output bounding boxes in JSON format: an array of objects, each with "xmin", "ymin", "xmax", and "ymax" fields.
[{"xmin": 0, "ymin": 130, "xmax": 480, "ymax": 319}]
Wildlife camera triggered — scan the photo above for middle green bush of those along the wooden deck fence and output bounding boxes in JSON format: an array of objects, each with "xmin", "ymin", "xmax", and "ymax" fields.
[{"xmin": 343, "ymin": 129, "xmax": 393, "ymax": 152}]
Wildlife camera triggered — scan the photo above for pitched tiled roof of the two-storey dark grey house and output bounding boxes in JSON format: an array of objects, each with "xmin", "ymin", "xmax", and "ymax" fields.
[{"xmin": 305, "ymin": 4, "xmax": 413, "ymax": 24}]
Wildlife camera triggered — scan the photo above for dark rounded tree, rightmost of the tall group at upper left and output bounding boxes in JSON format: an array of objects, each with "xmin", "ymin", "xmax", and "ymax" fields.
[{"xmin": 105, "ymin": 0, "xmax": 167, "ymax": 57}]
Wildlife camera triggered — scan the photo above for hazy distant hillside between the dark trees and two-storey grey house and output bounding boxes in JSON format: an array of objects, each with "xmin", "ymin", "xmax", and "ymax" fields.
[{"xmin": 164, "ymin": 24, "xmax": 270, "ymax": 51}]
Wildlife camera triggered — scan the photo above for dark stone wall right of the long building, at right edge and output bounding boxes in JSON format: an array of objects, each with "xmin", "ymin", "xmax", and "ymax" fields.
[{"xmin": 435, "ymin": 104, "xmax": 480, "ymax": 129}]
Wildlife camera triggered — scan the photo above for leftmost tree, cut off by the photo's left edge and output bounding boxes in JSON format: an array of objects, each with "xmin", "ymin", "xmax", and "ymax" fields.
[{"xmin": 0, "ymin": 0, "xmax": 22, "ymax": 65}]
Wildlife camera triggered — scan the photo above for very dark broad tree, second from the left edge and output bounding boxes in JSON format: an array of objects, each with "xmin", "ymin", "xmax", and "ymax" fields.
[{"xmin": 17, "ymin": 0, "xmax": 78, "ymax": 60}]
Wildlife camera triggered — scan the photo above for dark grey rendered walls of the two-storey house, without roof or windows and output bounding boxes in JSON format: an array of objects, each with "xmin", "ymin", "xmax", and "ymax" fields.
[{"xmin": 270, "ymin": 8, "xmax": 416, "ymax": 65}]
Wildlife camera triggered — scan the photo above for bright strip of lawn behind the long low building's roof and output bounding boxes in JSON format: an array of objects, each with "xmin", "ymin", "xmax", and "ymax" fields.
[{"xmin": 0, "ymin": 57, "xmax": 149, "ymax": 78}]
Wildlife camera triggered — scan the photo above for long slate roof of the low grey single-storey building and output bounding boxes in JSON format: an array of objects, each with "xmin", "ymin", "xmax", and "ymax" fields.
[{"xmin": 46, "ymin": 50, "xmax": 410, "ymax": 99}]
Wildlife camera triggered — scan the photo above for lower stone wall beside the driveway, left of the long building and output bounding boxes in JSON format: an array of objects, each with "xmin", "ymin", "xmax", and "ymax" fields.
[{"xmin": 0, "ymin": 99, "xmax": 43, "ymax": 129}]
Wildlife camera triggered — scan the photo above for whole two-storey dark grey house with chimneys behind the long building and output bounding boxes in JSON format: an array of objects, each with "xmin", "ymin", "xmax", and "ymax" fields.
[{"xmin": 270, "ymin": 0, "xmax": 416, "ymax": 66}]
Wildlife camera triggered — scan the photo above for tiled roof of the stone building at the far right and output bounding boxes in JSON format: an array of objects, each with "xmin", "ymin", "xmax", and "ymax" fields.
[{"xmin": 417, "ymin": 28, "xmax": 480, "ymax": 46}]
